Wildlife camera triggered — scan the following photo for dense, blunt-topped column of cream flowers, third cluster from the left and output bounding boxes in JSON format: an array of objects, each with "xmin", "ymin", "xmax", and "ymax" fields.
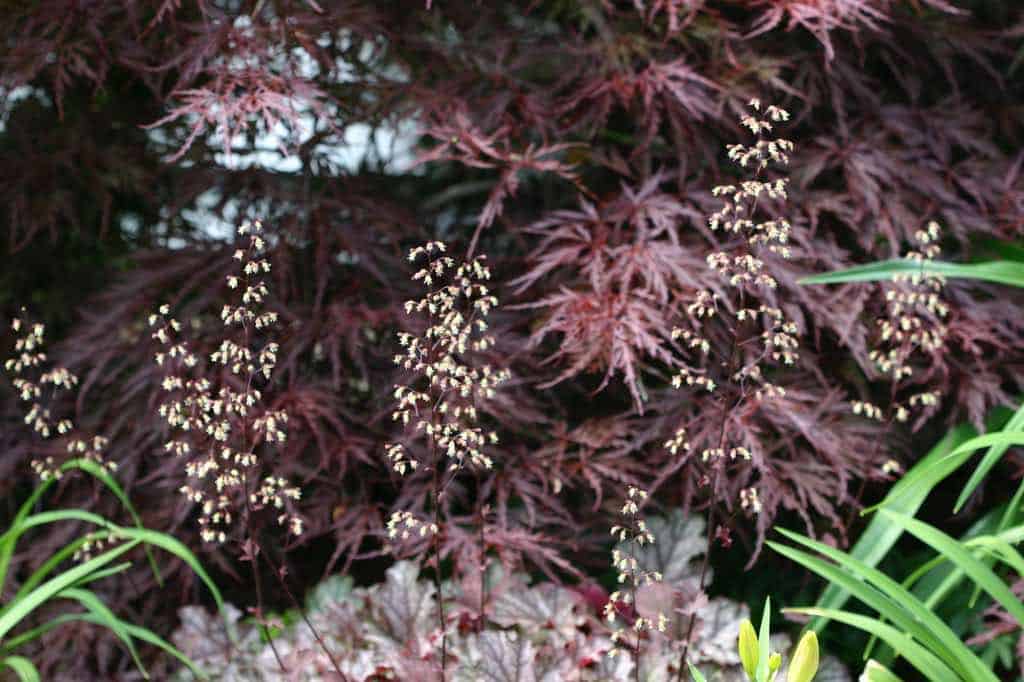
[{"xmin": 385, "ymin": 242, "xmax": 510, "ymax": 474}]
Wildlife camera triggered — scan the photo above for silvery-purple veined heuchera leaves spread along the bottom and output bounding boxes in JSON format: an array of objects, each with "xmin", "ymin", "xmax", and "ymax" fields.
[{"xmin": 173, "ymin": 511, "xmax": 850, "ymax": 682}]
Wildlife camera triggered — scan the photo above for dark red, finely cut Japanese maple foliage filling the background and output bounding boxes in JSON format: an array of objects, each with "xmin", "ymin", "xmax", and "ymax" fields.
[{"xmin": 0, "ymin": 0, "xmax": 1024, "ymax": 679}]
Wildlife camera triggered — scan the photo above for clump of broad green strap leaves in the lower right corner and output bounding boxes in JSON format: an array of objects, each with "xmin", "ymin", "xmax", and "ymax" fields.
[{"xmin": 768, "ymin": 407, "xmax": 1024, "ymax": 681}]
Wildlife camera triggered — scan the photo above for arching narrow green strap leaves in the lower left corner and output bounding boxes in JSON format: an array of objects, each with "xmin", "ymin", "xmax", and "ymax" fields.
[{"xmin": 0, "ymin": 460, "xmax": 222, "ymax": 682}]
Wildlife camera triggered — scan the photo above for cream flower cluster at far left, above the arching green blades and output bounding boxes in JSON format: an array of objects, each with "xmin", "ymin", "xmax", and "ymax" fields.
[{"xmin": 4, "ymin": 317, "xmax": 116, "ymax": 480}]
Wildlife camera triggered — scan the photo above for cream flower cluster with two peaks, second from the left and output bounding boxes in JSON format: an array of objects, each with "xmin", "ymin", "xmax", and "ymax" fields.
[{"xmin": 150, "ymin": 222, "xmax": 303, "ymax": 543}]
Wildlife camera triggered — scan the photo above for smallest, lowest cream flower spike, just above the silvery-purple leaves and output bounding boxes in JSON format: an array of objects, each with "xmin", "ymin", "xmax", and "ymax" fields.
[{"xmin": 604, "ymin": 485, "xmax": 669, "ymax": 658}]
